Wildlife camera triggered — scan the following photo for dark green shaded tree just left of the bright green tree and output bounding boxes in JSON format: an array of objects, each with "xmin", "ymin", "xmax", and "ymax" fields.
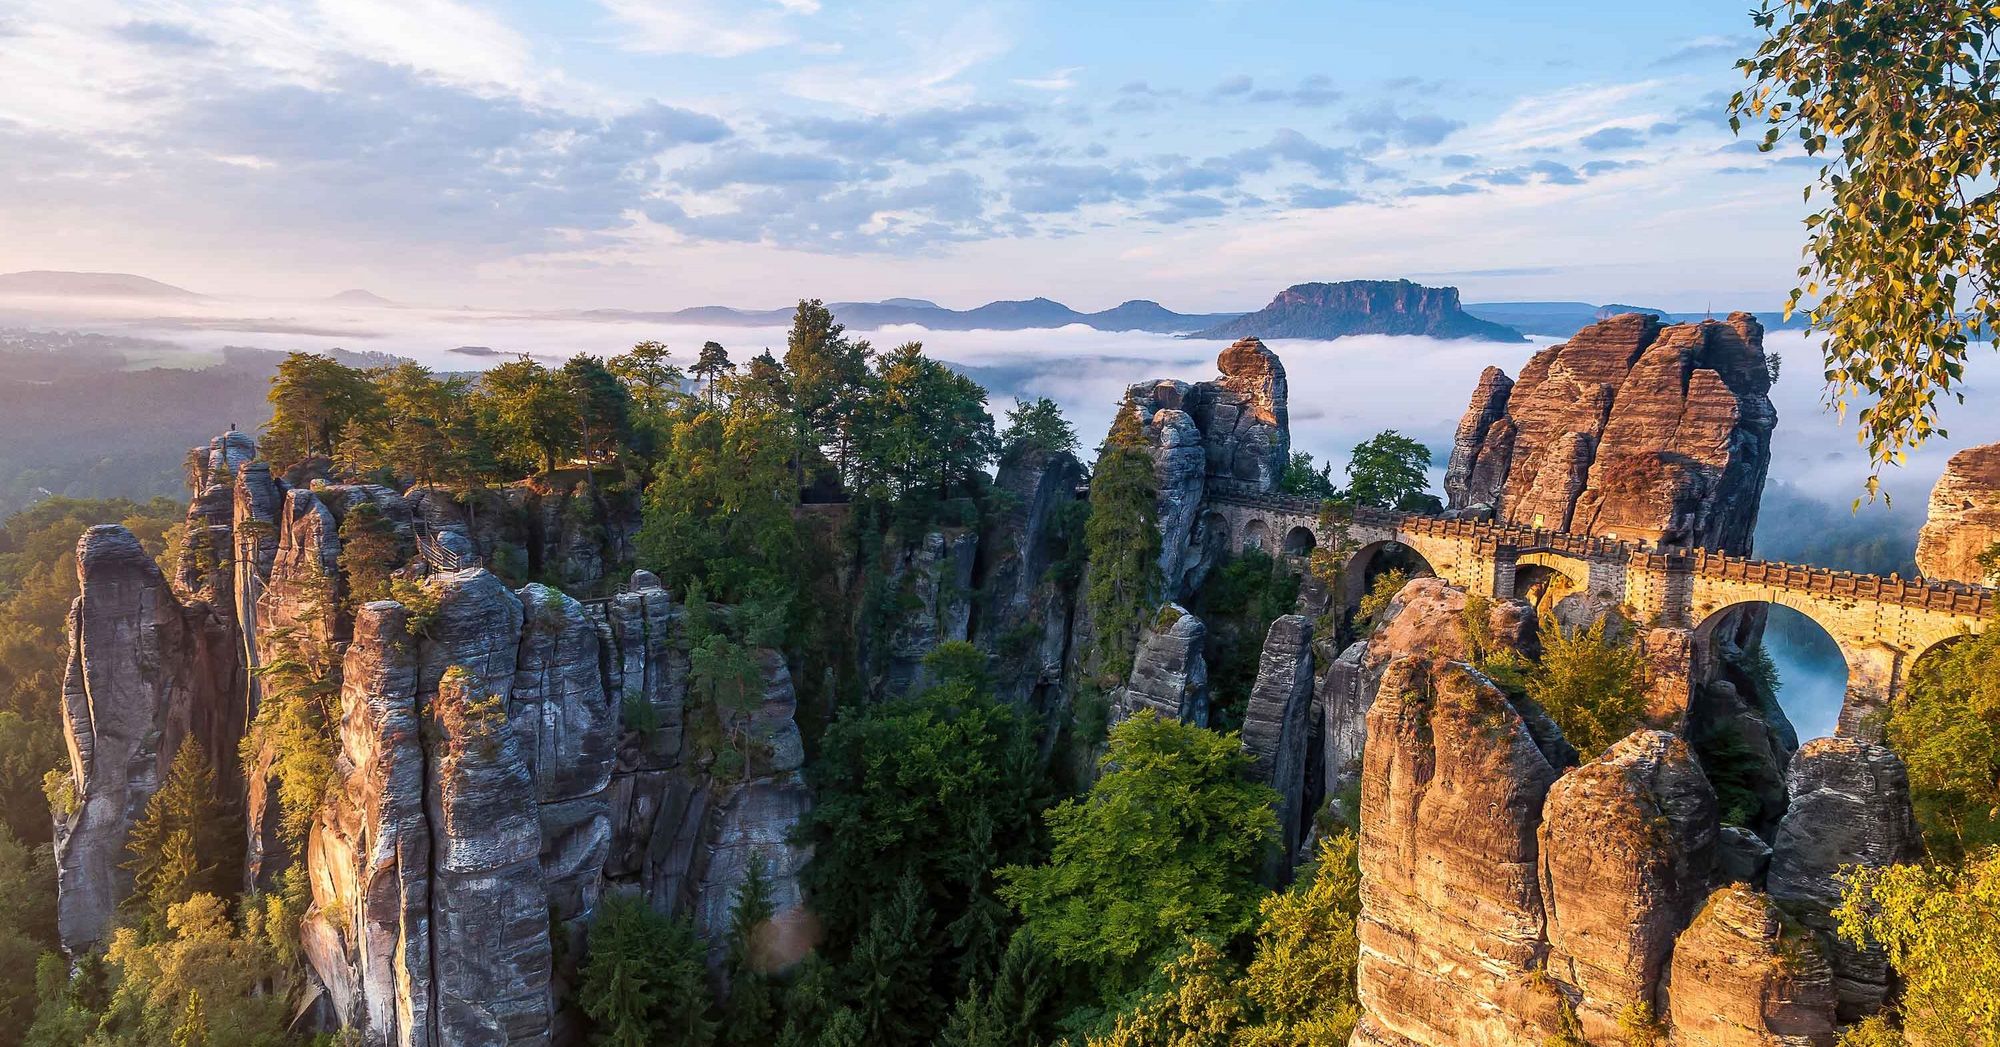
[{"xmin": 802, "ymin": 671, "xmax": 1042, "ymax": 995}]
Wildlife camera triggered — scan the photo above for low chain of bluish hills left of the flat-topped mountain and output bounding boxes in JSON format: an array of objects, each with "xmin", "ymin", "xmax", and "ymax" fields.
[{"xmin": 578, "ymin": 298, "xmax": 1238, "ymax": 334}]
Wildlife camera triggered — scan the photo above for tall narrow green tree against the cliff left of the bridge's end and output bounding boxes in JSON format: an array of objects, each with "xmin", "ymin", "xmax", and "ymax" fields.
[{"xmin": 1084, "ymin": 396, "xmax": 1160, "ymax": 685}]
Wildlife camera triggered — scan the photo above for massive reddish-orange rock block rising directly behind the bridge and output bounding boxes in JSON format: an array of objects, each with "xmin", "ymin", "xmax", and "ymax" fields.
[{"xmin": 1446, "ymin": 314, "xmax": 1778, "ymax": 553}]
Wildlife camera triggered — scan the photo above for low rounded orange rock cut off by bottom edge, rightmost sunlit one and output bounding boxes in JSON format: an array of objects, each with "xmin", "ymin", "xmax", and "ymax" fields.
[{"xmin": 1668, "ymin": 883, "xmax": 1834, "ymax": 1047}]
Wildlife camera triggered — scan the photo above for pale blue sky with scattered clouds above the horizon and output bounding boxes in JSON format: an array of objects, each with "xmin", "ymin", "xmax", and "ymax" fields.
[{"xmin": 0, "ymin": 0, "xmax": 1810, "ymax": 310}]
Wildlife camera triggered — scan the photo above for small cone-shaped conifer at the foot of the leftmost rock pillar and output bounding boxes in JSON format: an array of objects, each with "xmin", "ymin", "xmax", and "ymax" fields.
[{"xmin": 120, "ymin": 737, "xmax": 242, "ymax": 937}]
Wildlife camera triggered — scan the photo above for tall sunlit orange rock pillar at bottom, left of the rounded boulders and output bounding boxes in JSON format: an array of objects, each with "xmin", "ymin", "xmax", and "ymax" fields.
[{"xmin": 1354, "ymin": 655, "xmax": 1560, "ymax": 1047}]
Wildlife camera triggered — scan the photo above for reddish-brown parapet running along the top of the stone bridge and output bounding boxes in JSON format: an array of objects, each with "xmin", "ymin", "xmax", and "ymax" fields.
[{"xmin": 1208, "ymin": 482, "xmax": 2000, "ymax": 617}]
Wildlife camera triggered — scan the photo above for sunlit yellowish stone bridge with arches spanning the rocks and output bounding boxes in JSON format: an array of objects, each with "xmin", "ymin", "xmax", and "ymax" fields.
[{"xmin": 1198, "ymin": 484, "xmax": 1996, "ymax": 735}]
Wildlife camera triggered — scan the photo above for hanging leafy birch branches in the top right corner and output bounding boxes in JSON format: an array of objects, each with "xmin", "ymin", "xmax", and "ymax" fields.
[{"xmin": 1730, "ymin": 0, "xmax": 2000, "ymax": 496}]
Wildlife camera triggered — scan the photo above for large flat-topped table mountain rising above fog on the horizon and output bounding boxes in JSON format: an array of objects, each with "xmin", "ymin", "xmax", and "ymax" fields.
[{"xmin": 1188, "ymin": 280, "xmax": 1524, "ymax": 342}]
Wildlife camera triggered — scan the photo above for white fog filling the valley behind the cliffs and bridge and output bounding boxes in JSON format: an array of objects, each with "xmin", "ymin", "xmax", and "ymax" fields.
[{"xmin": 0, "ymin": 289, "xmax": 2000, "ymax": 737}]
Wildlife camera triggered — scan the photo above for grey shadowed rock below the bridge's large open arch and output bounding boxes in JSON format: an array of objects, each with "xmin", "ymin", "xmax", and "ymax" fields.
[{"xmin": 1768, "ymin": 737, "xmax": 1924, "ymax": 1021}]
